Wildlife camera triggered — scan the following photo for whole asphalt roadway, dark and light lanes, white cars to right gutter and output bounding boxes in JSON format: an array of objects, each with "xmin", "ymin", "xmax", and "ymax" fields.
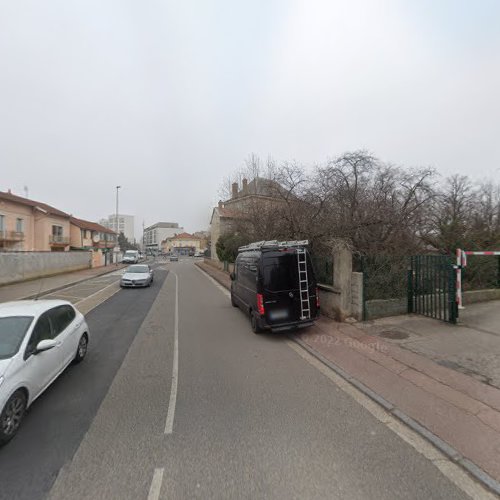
[{"xmin": 26, "ymin": 261, "xmax": 472, "ymax": 499}]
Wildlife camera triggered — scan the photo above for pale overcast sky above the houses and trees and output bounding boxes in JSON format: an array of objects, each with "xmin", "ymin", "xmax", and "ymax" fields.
[{"xmin": 0, "ymin": 0, "xmax": 500, "ymax": 236}]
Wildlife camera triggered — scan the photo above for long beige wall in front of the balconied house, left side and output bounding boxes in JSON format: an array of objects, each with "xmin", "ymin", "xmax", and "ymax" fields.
[{"xmin": 0, "ymin": 252, "xmax": 92, "ymax": 285}]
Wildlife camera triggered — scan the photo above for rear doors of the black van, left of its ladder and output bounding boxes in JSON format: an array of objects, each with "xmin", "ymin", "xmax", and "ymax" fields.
[{"xmin": 261, "ymin": 250, "xmax": 300, "ymax": 325}]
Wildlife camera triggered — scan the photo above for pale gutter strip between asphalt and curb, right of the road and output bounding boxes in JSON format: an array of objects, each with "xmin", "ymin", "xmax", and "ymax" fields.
[{"xmin": 286, "ymin": 340, "xmax": 497, "ymax": 500}]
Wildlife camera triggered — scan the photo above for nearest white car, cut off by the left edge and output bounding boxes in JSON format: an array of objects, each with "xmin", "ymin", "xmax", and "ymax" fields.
[{"xmin": 0, "ymin": 300, "xmax": 89, "ymax": 446}]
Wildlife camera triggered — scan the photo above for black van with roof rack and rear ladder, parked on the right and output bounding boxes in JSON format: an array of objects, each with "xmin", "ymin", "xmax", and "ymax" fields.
[{"xmin": 231, "ymin": 240, "xmax": 319, "ymax": 333}]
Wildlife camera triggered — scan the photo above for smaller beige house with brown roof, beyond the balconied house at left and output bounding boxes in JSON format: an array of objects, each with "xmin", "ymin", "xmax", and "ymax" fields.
[{"xmin": 70, "ymin": 217, "xmax": 118, "ymax": 267}]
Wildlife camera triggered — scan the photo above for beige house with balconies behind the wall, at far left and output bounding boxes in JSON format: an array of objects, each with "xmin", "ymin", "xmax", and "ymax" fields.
[{"xmin": 0, "ymin": 191, "xmax": 70, "ymax": 252}]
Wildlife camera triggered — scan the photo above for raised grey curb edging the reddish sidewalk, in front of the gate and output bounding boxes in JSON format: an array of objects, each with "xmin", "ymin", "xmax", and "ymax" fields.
[{"xmin": 289, "ymin": 335, "xmax": 500, "ymax": 495}]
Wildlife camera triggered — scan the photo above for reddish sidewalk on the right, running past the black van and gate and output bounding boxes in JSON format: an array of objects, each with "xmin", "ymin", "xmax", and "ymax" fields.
[{"xmin": 198, "ymin": 263, "xmax": 500, "ymax": 493}]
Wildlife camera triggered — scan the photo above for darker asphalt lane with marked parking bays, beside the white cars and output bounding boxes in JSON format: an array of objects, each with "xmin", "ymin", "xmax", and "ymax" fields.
[{"xmin": 0, "ymin": 262, "xmax": 167, "ymax": 500}]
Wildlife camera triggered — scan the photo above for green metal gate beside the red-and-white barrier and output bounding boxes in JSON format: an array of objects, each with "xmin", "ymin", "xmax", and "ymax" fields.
[{"xmin": 408, "ymin": 255, "xmax": 458, "ymax": 323}]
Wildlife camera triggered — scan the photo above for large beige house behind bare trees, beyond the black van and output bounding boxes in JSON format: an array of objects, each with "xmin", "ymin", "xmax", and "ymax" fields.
[{"xmin": 210, "ymin": 177, "xmax": 282, "ymax": 261}]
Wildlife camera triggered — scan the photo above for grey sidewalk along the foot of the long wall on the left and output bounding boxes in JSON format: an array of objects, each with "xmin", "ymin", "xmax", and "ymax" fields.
[{"xmin": 0, "ymin": 264, "xmax": 126, "ymax": 302}]
